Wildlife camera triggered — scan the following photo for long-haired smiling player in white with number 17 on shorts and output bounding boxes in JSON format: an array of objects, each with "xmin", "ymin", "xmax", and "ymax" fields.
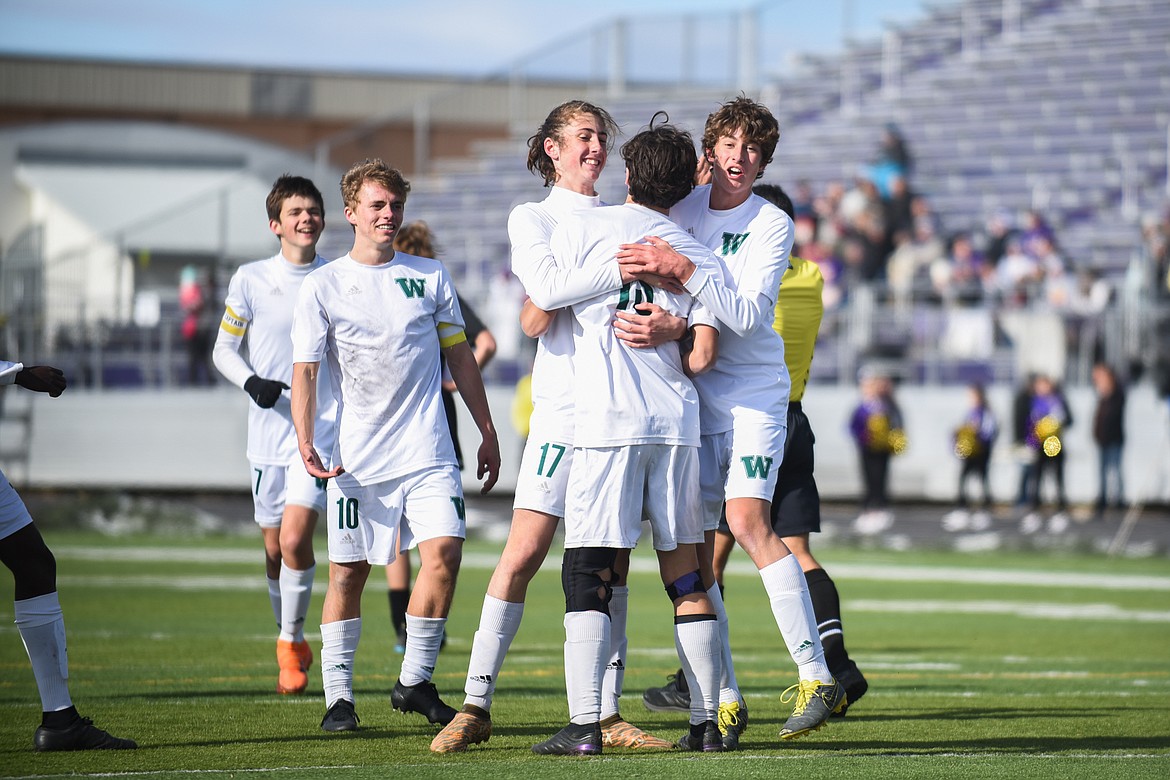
[{"xmin": 431, "ymin": 101, "xmax": 683, "ymax": 753}]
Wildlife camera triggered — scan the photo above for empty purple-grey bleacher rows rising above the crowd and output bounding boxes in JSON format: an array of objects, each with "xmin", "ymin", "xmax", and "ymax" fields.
[{"xmin": 411, "ymin": 0, "xmax": 1170, "ymax": 301}]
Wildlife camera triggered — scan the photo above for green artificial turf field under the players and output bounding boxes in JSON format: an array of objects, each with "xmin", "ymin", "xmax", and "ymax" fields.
[{"xmin": 0, "ymin": 530, "xmax": 1170, "ymax": 780}]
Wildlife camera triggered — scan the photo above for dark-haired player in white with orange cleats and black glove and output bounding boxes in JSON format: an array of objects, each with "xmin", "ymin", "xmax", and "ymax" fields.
[{"xmin": 212, "ymin": 175, "xmax": 337, "ymax": 693}]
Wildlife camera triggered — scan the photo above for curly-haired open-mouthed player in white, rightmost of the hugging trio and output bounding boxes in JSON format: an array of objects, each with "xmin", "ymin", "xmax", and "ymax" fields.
[{"xmin": 618, "ymin": 97, "xmax": 846, "ymax": 739}]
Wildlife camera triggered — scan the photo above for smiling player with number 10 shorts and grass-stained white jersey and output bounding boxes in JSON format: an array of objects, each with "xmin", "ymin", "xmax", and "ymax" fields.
[{"xmin": 293, "ymin": 160, "xmax": 500, "ymax": 731}]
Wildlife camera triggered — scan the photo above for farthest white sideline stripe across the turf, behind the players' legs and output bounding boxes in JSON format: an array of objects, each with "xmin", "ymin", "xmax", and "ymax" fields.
[{"xmin": 53, "ymin": 544, "xmax": 1170, "ymax": 591}]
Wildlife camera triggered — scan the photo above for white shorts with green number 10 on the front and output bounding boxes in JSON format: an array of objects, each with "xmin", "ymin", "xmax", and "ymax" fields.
[{"xmin": 324, "ymin": 465, "xmax": 467, "ymax": 566}]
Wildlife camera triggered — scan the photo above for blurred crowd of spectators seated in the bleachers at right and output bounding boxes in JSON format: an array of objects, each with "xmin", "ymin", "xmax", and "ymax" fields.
[{"xmin": 776, "ymin": 125, "xmax": 1113, "ymax": 327}]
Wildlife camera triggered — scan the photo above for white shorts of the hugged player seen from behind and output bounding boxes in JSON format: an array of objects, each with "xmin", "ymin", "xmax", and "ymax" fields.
[{"xmin": 565, "ymin": 444, "xmax": 703, "ymax": 550}]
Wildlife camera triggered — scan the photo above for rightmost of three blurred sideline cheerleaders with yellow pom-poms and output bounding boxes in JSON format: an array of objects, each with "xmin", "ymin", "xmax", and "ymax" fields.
[{"xmin": 1020, "ymin": 374, "xmax": 1073, "ymax": 533}]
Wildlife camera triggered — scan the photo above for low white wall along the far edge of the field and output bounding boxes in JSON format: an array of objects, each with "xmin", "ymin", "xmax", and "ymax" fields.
[{"xmin": 14, "ymin": 385, "xmax": 1170, "ymax": 503}]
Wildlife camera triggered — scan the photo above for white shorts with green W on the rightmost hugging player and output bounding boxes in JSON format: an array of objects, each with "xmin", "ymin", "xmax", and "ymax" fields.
[{"xmin": 698, "ymin": 415, "xmax": 786, "ymax": 531}]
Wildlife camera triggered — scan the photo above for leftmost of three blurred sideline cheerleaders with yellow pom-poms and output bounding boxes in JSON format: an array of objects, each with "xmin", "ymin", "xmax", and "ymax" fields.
[{"xmin": 849, "ymin": 368, "xmax": 906, "ymax": 534}]
